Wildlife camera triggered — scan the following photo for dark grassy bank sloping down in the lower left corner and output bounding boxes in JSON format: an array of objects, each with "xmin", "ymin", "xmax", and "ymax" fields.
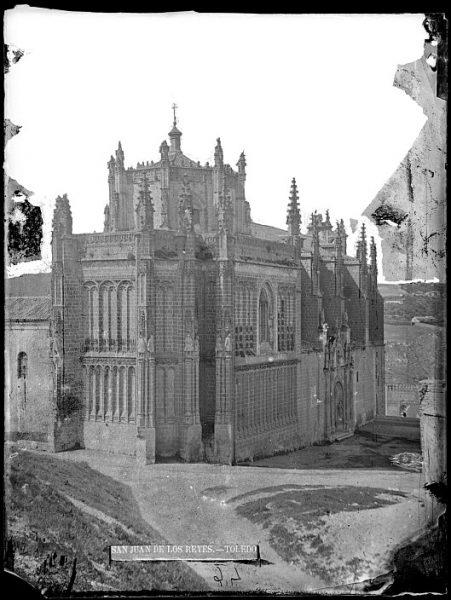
[{"xmin": 5, "ymin": 449, "xmax": 206, "ymax": 594}]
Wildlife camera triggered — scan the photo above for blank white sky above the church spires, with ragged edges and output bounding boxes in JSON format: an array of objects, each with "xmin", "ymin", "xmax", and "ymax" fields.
[{"xmin": 5, "ymin": 5, "xmax": 426, "ymax": 280}]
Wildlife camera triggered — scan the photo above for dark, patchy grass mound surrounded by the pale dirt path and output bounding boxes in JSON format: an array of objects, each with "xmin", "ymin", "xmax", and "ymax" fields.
[{"xmin": 233, "ymin": 485, "xmax": 406, "ymax": 585}]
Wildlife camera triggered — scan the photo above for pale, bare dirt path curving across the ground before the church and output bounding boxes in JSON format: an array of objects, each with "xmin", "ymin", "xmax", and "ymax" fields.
[{"xmin": 57, "ymin": 450, "xmax": 424, "ymax": 592}]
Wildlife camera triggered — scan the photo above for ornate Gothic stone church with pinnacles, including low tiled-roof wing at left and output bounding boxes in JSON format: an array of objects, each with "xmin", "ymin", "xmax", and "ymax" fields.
[{"xmin": 5, "ymin": 120, "xmax": 385, "ymax": 464}]
